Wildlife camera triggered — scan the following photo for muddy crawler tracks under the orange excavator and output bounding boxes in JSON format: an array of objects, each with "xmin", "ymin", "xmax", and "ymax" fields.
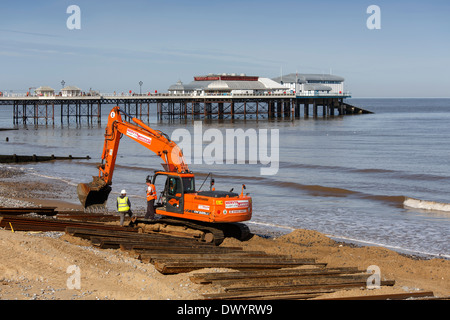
[{"xmin": 130, "ymin": 217, "xmax": 250, "ymax": 246}]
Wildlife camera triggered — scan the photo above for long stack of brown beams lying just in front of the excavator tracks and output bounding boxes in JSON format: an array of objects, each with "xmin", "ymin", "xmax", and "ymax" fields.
[{"xmin": 66, "ymin": 227, "xmax": 325, "ymax": 274}]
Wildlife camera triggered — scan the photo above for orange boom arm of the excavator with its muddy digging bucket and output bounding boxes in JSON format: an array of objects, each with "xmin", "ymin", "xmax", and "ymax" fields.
[{"xmin": 77, "ymin": 107, "xmax": 189, "ymax": 208}]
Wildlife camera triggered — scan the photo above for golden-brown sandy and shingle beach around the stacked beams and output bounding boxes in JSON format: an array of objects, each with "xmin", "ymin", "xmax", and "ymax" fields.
[{"xmin": 0, "ymin": 167, "xmax": 450, "ymax": 300}]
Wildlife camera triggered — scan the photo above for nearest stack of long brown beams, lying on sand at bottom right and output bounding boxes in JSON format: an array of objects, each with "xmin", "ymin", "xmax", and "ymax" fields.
[{"xmin": 190, "ymin": 264, "xmax": 395, "ymax": 300}]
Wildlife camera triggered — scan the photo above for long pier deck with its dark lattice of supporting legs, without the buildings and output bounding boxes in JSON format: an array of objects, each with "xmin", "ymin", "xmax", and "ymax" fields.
[{"xmin": 0, "ymin": 93, "xmax": 371, "ymax": 125}]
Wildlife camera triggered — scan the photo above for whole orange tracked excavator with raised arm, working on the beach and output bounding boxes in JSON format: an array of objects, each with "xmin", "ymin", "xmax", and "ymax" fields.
[{"xmin": 77, "ymin": 107, "xmax": 252, "ymax": 245}]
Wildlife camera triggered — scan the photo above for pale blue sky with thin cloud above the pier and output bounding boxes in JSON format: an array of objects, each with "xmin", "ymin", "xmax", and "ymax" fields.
[{"xmin": 0, "ymin": 0, "xmax": 450, "ymax": 97}]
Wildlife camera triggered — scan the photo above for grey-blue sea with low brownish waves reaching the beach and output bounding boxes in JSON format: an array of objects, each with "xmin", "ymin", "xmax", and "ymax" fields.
[{"xmin": 0, "ymin": 98, "xmax": 450, "ymax": 259}]
